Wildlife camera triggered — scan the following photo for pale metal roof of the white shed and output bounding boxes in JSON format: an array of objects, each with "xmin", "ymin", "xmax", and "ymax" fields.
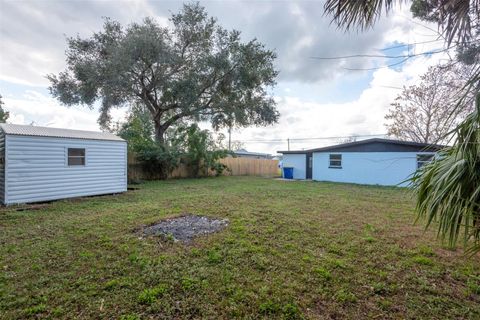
[{"xmin": 0, "ymin": 123, "xmax": 125, "ymax": 141}]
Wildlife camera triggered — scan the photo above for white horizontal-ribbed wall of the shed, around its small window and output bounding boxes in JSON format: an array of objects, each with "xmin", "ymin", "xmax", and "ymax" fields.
[{"xmin": 4, "ymin": 135, "xmax": 127, "ymax": 204}]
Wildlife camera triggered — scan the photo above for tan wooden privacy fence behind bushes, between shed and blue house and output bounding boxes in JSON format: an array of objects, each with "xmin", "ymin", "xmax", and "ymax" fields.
[{"xmin": 128, "ymin": 153, "xmax": 280, "ymax": 181}]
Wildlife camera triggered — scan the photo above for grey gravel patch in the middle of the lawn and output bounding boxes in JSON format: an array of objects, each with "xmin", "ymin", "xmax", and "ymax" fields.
[{"xmin": 143, "ymin": 215, "xmax": 228, "ymax": 243}]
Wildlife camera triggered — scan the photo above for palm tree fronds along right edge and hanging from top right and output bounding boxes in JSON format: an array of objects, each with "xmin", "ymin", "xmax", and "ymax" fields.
[{"xmin": 325, "ymin": 0, "xmax": 480, "ymax": 253}]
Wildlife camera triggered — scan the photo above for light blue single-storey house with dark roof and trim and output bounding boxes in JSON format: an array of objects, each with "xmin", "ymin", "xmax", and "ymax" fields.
[{"xmin": 279, "ymin": 138, "xmax": 444, "ymax": 186}]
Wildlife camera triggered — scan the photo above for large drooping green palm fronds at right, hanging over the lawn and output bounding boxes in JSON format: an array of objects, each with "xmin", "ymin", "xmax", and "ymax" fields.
[{"xmin": 411, "ymin": 89, "xmax": 480, "ymax": 253}]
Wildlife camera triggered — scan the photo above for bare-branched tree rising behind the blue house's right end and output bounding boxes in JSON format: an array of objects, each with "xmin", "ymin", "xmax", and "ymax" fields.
[{"xmin": 385, "ymin": 64, "xmax": 474, "ymax": 144}]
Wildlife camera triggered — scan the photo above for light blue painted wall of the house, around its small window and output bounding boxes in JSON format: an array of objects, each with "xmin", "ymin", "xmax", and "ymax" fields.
[{"xmin": 312, "ymin": 152, "xmax": 433, "ymax": 186}]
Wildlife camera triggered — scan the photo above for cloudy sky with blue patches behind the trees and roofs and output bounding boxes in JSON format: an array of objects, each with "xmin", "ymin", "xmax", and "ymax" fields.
[{"xmin": 0, "ymin": 0, "xmax": 454, "ymax": 153}]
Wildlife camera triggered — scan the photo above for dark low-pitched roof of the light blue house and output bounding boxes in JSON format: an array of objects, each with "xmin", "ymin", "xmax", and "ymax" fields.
[{"xmin": 278, "ymin": 138, "xmax": 445, "ymax": 154}]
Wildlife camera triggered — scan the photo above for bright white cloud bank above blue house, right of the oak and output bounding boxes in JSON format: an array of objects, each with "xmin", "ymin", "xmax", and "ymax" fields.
[{"xmin": 227, "ymin": 51, "xmax": 452, "ymax": 153}]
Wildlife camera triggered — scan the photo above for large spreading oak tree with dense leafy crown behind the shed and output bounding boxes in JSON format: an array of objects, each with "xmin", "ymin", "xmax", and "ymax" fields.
[{"xmin": 48, "ymin": 4, "xmax": 279, "ymax": 143}]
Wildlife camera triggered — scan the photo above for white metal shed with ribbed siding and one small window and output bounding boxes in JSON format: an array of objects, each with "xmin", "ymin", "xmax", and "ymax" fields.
[{"xmin": 0, "ymin": 124, "xmax": 127, "ymax": 205}]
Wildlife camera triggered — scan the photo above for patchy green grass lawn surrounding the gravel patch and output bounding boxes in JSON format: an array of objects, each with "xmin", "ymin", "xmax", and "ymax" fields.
[{"xmin": 0, "ymin": 177, "xmax": 480, "ymax": 319}]
